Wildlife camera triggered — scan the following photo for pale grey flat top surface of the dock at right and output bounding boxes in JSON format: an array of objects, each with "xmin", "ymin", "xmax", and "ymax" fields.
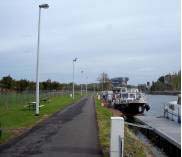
[{"xmin": 136, "ymin": 116, "xmax": 181, "ymax": 149}]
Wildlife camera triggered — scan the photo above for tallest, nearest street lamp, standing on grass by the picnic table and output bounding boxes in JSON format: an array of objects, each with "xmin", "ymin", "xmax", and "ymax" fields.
[{"xmin": 36, "ymin": 4, "xmax": 49, "ymax": 115}]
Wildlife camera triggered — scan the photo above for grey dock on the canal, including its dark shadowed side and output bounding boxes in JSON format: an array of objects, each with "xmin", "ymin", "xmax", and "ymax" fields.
[{"xmin": 135, "ymin": 116, "xmax": 181, "ymax": 157}]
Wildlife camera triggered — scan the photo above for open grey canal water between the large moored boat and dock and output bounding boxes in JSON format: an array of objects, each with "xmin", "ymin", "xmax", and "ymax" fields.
[{"xmin": 144, "ymin": 95, "xmax": 177, "ymax": 116}]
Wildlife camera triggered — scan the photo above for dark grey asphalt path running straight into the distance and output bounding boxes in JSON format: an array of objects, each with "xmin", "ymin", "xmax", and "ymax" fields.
[{"xmin": 0, "ymin": 97, "xmax": 101, "ymax": 157}]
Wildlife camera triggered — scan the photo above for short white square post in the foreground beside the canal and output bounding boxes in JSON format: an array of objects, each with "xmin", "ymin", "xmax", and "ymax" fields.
[{"xmin": 110, "ymin": 117, "xmax": 124, "ymax": 157}]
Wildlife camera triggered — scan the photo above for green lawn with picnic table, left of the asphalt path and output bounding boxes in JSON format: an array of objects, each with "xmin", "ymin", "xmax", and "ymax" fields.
[{"xmin": 0, "ymin": 94, "xmax": 81, "ymax": 143}]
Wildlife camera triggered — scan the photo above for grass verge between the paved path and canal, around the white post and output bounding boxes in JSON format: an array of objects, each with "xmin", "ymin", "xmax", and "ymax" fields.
[{"xmin": 96, "ymin": 100, "xmax": 148, "ymax": 157}]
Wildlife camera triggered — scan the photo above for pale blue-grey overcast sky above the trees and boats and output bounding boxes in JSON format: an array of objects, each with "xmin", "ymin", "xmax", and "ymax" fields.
[{"xmin": 0, "ymin": 0, "xmax": 180, "ymax": 84}]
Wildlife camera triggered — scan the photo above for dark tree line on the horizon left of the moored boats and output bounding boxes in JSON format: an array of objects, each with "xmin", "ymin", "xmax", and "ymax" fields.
[{"xmin": 0, "ymin": 73, "xmax": 106, "ymax": 92}]
